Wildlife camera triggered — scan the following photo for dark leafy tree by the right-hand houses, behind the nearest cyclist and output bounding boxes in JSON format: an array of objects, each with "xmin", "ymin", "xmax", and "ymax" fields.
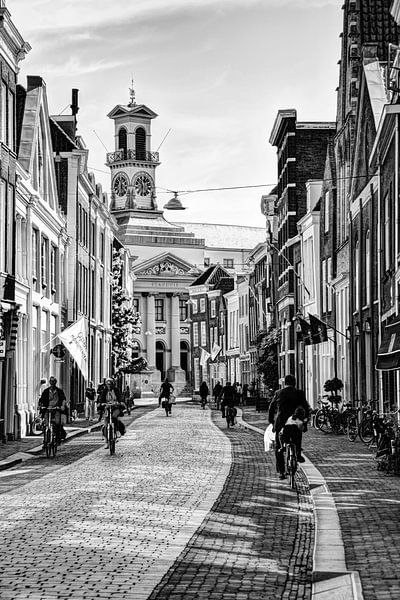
[{"xmin": 256, "ymin": 327, "xmax": 281, "ymax": 390}]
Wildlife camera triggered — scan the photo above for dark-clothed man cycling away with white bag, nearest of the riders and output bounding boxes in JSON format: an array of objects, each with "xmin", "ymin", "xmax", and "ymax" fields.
[{"xmin": 268, "ymin": 375, "xmax": 310, "ymax": 479}]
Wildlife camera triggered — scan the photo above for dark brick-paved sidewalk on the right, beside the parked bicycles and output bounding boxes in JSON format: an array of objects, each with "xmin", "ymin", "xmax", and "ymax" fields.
[{"xmin": 243, "ymin": 407, "xmax": 400, "ymax": 600}]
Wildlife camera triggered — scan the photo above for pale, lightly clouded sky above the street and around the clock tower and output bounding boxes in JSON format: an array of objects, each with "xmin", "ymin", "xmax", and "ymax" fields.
[{"xmin": 10, "ymin": 0, "xmax": 342, "ymax": 227}]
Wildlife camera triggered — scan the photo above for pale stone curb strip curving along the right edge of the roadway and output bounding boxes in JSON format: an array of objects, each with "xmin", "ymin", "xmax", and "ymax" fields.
[{"xmin": 237, "ymin": 408, "xmax": 364, "ymax": 600}]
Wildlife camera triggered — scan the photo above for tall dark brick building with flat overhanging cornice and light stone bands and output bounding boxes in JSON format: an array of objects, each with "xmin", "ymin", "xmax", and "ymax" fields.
[{"xmin": 270, "ymin": 109, "xmax": 336, "ymax": 385}]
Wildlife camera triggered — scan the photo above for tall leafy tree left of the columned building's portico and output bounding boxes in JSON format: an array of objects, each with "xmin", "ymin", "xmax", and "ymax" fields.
[{"xmin": 112, "ymin": 249, "xmax": 140, "ymax": 372}]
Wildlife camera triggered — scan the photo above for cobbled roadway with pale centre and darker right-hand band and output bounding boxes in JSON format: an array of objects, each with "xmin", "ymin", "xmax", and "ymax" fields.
[{"xmin": 0, "ymin": 405, "xmax": 313, "ymax": 600}]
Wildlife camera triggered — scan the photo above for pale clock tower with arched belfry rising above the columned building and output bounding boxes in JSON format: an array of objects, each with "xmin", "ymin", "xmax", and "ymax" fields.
[{"xmin": 107, "ymin": 82, "xmax": 160, "ymax": 213}]
